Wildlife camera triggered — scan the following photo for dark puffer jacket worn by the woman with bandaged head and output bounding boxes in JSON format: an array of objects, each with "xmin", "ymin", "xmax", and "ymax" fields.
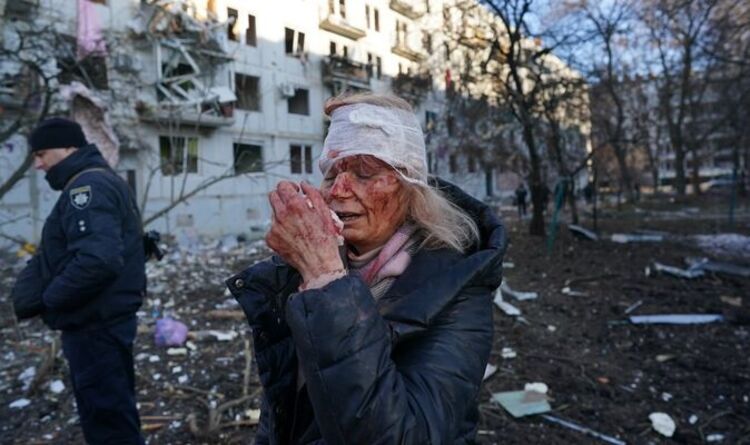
[{"xmin": 227, "ymin": 182, "xmax": 506, "ymax": 445}]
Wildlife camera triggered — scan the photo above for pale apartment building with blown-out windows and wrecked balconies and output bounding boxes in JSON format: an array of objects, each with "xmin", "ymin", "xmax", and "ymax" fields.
[{"xmin": 0, "ymin": 0, "xmax": 592, "ymax": 239}]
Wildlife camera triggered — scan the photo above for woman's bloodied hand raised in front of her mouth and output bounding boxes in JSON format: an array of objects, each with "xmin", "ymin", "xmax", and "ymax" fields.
[{"xmin": 266, "ymin": 181, "xmax": 344, "ymax": 282}]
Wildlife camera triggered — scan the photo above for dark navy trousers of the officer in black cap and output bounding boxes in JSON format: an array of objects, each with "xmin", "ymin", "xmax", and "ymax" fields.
[{"xmin": 62, "ymin": 317, "xmax": 144, "ymax": 445}]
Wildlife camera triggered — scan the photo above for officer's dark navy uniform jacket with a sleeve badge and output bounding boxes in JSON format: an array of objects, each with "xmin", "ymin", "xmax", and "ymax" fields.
[{"xmin": 13, "ymin": 145, "xmax": 146, "ymax": 330}]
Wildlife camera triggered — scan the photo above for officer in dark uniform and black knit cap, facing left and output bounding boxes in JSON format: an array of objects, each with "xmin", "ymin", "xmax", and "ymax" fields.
[{"xmin": 13, "ymin": 118, "xmax": 146, "ymax": 445}]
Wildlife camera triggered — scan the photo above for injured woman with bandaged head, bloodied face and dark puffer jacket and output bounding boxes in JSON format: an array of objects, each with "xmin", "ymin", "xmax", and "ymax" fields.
[{"xmin": 227, "ymin": 95, "xmax": 506, "ymax": 445}]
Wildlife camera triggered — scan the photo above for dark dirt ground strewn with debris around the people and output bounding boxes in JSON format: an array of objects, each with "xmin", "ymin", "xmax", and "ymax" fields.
[{"xmin": 0, "ymin": 193, "xmax": 750, "ymax": 444}]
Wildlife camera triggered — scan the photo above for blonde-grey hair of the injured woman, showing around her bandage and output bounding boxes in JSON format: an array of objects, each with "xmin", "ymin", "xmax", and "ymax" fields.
[{"xmin": 325, "ymin": 93, "xmax": 479, "ymax": 253}]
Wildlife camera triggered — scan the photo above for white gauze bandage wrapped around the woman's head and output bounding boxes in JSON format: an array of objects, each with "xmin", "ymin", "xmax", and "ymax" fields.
[{"xmin": 318, "ymin": 103, "xmax": 427, "ymax": 185}]
